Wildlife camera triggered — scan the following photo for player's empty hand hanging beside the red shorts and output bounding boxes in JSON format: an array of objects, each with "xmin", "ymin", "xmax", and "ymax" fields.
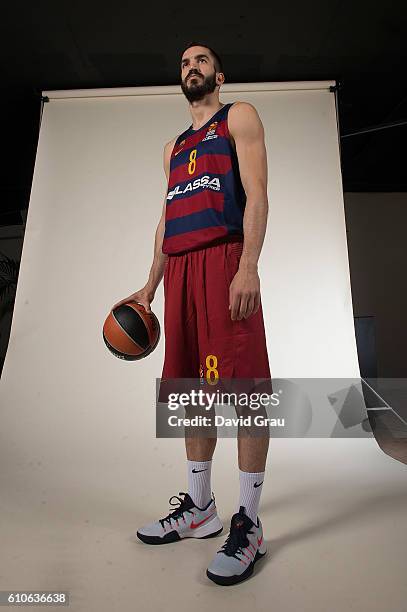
[{"xmin": 229, "ymin": 266, "xmax": 260, "ymax": 321}]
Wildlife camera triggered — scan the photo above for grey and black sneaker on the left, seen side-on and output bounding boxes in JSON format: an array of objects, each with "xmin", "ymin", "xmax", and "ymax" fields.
[{"xmin": 137, "ymin": 492, "xmax": 223, "ymax": 544}]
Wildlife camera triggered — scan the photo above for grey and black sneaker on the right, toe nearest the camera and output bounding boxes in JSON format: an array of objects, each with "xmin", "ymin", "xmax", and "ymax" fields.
[{"xmin": 206, "ymin": 506, "xmax": 267, "ymax": 585}]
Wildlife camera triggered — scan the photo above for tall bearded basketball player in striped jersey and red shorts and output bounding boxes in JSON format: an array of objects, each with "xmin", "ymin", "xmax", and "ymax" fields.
[{"xmin": 114, "ymin": 42, "xmax": 270, "ymax": 585}]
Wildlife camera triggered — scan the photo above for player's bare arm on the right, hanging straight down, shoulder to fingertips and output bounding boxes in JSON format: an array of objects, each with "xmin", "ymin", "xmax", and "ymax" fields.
[{"xmin": 228, "ymin": 102, "xmax": 268, "ymax": 320}]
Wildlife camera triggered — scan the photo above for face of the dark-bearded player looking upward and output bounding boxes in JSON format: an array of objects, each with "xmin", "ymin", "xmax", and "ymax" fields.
[{"xmin": 181, "ymin": 47, "xmax": 220, "ymax": 102}]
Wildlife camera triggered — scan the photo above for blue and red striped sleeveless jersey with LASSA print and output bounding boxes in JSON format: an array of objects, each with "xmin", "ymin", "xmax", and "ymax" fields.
[{"xmin": 162, "ymin": 102, "xmax": 246, "ymax": 255}]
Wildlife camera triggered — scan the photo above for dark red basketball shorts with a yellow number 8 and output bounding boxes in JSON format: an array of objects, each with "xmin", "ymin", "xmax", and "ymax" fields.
[{"xmin": 162, "ymin": 241, "xmax": 271, "ymax": 402}]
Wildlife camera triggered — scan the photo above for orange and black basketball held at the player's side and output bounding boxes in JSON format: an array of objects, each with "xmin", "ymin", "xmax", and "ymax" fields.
[{"xmin": 103, "ymin": 302, "xmax": 160, "ymax": 361}]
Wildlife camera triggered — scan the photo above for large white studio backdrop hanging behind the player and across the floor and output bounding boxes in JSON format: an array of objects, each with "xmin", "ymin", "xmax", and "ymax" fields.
[{"xmin": 0, "ymin": 81, "xmax": 405, "ymax": 612}]
